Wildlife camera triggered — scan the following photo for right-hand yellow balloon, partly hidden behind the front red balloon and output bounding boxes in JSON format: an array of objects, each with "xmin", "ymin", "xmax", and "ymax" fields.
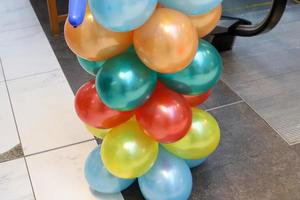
[{"xmin": 163, "ymin": 108, "xmax": 220, "ymax": 160}]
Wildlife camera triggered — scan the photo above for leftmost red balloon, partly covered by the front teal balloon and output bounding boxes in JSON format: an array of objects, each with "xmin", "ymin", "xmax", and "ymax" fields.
[{"xmin": 75, "ymin": 80, "xmax": 133, "ymax": 128}]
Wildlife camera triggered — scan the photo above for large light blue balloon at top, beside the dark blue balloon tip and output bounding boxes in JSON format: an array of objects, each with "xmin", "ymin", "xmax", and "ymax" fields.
[{"xmin": 89, "ymin": 0, "xmax": 157, "ymax": 32}]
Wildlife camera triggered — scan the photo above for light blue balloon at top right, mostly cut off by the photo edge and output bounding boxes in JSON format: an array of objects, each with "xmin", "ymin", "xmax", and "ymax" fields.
[{"xmin": 159, "ymin": 0, "xmax": 222, "ymax": 15}]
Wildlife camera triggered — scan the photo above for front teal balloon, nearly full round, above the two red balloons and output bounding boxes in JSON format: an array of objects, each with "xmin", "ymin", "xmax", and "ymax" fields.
[{"xmin": 96, "ymin": 52, "xmax": 157, "ymax": 111}]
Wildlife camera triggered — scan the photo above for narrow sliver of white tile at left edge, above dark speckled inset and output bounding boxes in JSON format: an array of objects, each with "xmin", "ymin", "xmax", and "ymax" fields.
[{"xmin": 0, "ymin": 82, "xmax": 20, "ymax": 154}]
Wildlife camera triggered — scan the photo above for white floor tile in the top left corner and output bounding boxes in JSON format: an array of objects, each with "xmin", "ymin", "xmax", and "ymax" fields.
[{"xmin": 0, "ymin": 0, "xmax": 39, "ymax": 32}]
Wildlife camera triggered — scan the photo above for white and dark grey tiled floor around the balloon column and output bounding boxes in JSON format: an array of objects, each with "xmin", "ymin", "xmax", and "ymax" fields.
[{"xmin": 0, "ymin": 0, "xmax": 300, "ymax": 200}]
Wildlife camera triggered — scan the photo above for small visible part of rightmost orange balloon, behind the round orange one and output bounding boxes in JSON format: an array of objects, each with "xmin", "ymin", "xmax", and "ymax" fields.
[{"xmin": 190, "ymin": 5, "xmax": 222, "ymax": 38}]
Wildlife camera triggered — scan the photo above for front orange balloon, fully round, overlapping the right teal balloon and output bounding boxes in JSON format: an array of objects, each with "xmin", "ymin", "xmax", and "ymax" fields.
[{"xmin": 133, "ymin": 8, "xmax": 198, "ymax": 73}]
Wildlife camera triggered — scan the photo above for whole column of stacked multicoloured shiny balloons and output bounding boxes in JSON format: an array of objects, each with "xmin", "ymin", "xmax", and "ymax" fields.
[{"xmin": 65, "ymin": 0, "xmax": 222, "ymax": 200}]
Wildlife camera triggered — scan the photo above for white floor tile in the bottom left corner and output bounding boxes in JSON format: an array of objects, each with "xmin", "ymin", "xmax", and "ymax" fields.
[{"xmin": 0, "ymin": 158, "xmax": 34, "ymax": 200}]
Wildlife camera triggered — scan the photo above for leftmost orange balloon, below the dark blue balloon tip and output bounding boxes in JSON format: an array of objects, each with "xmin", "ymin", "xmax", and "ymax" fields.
[{"xmin": 65, "ymin": 8, "xmax": 133, "ymax": 61}]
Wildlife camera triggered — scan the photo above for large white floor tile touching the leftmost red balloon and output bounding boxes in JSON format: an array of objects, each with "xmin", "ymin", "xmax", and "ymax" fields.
[{"xmin": 8, "ymin": 71, "xmax": 92, "ymax": 155}]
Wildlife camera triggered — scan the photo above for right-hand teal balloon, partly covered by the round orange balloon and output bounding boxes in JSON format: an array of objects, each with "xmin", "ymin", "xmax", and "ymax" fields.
[{"xmin": 158, "ymin": 40, "xmax": 223, "ymax": 95}]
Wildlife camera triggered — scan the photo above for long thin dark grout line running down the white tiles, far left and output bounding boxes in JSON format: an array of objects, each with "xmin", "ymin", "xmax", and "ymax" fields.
[{"xmin": 0, "ymin": 57, "xmax": 36, "ymax": 200}]
